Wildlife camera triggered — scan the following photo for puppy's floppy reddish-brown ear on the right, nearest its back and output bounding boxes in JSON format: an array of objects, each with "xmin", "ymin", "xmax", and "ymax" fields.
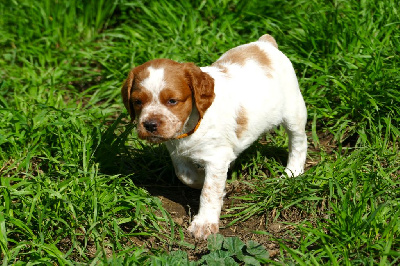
[{"xmin": 184, "ymin": 63, "xmax": 215, "ymax": 117}]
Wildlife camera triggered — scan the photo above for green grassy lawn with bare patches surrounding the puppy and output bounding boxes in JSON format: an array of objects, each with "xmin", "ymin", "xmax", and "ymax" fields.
[{"xmin": 0, "ymin": 0, "xmax": 400, "ymax": 265}]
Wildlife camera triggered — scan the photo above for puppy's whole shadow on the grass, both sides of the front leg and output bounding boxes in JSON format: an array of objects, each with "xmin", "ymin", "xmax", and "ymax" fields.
[{"xmin": 94, "ymin": 115, "xmax": 287, "ymax": 214}]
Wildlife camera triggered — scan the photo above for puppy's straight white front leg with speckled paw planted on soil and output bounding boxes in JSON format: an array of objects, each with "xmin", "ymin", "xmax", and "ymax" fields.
[{"xmin": 188, "ymin": 163, "xmax": 229, "ymax": 239}]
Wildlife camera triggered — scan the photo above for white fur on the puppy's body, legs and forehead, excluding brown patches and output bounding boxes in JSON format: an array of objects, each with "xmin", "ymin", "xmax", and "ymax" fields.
[{"xmin": 138, "ymin": 37, "xmax": 307, "ymax": 239}]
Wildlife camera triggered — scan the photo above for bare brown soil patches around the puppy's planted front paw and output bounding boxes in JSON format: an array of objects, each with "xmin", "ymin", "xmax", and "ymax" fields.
[{"xmin": 142, "ymin": 182, "xmax": 293, "ymax": 260}]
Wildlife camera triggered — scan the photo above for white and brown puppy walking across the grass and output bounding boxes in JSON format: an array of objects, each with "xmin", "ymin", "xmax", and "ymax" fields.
[{"xmin": 122, "ymin": 35, "xmax": 307, "ymax": 239}]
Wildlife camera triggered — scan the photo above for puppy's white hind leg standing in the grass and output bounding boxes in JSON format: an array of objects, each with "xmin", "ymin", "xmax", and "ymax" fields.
[{"xmin": 283, "ymin": 104, "xmax": 307, "ymax": 177}]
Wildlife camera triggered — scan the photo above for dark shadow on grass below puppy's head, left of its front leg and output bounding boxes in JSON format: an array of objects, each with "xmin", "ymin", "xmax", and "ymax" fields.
[{"xmin": 93, "ymin": 115, "xmax": 201, "ymax": 213}]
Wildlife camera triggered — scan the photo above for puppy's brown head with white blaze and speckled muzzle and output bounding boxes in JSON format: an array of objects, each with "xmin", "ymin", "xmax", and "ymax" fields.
[{"xmin": 121, "ymin": 59, "xmax": 214, "ymax": 143}]
